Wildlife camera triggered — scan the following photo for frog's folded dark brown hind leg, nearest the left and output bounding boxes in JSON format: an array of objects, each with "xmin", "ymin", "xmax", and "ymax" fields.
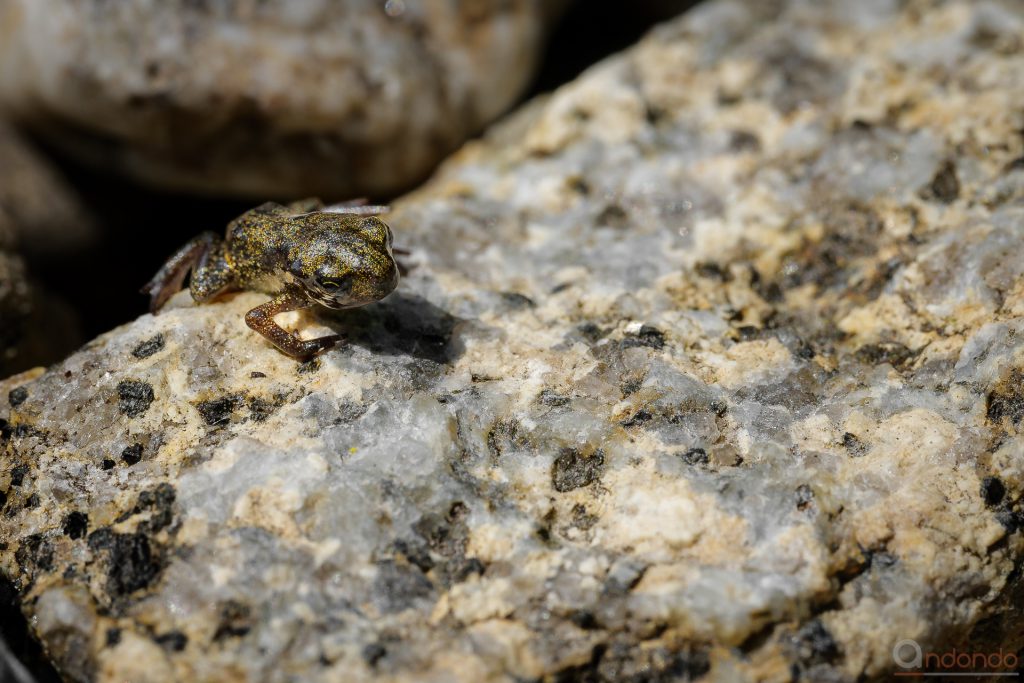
[{"xmin": 142, "ymin": 231, "xmax": 232, "ymax": 313}]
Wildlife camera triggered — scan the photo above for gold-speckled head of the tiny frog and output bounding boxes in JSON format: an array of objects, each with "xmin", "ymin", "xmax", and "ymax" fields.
[{"xmin": 288, "ymin": 212, "xmax": 398, "ymax": 308}]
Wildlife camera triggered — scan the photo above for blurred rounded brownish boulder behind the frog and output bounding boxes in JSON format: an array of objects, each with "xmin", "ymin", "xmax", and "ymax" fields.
[{"xmin": 0, "ymin": 0, "xmax": 565, "ymax": 200}]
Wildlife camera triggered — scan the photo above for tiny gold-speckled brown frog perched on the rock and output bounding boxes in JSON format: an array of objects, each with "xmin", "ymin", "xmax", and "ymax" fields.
[{"xmin": 142, "ymin": 200, "xmax": 402, "ymax": 359}]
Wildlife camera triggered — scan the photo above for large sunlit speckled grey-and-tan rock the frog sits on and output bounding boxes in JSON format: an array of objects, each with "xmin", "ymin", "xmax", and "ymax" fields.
[{"xmin": 0, "ymin": 0, "xmax": 1024, "ymax": 681}]
